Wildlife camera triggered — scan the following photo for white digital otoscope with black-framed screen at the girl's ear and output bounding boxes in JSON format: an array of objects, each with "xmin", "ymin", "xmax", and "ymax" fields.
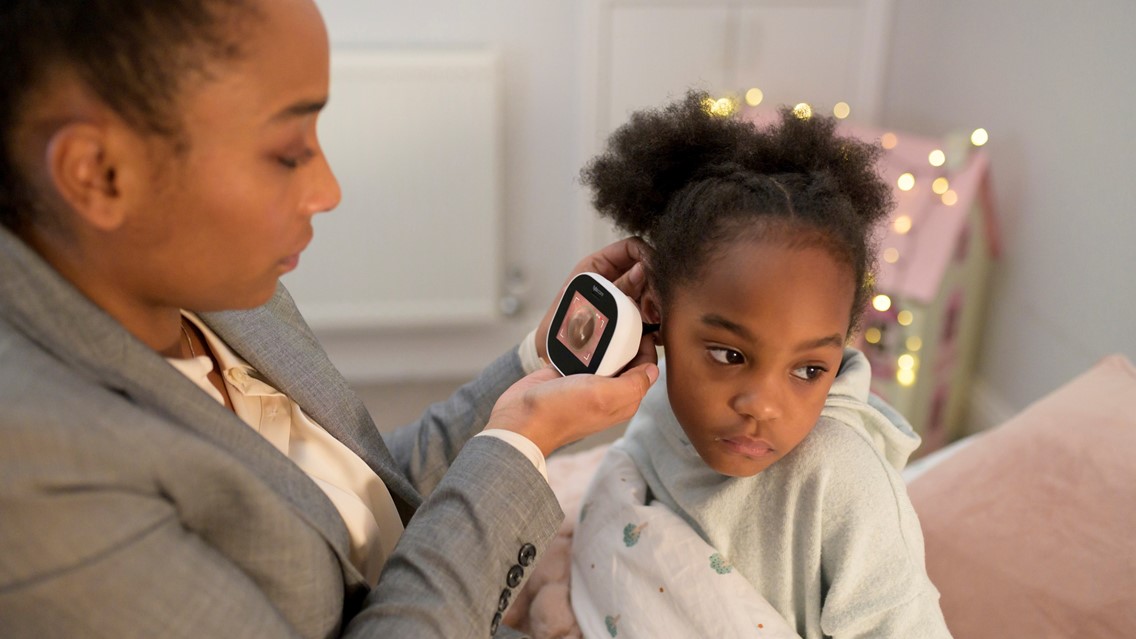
[{"xmin": 545, "ymin": 273, "xmax": 653, "ymax": 376}]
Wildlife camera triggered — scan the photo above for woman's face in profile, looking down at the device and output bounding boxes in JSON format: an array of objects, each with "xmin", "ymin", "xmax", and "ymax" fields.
[{"xmin": 117, "ymin": 0, "xmax": 340, "ymax": 310}]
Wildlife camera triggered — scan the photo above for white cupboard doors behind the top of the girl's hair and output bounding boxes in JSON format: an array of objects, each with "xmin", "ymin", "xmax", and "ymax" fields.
[{"xmin": 582, "ymin": 0, "xmax": 891, "ymax": 244}]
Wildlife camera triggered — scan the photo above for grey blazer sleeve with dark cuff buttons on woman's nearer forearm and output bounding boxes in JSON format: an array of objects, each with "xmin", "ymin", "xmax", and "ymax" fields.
[{"xmin": 345, "ymin": 438, "xmax": 563, "ymax": 639}]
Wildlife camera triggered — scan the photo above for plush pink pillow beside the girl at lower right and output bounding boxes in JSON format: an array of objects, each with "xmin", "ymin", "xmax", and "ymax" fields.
[{"xmin": 909, "ymin": 355, "xmax": 1136, "ymax": 639}]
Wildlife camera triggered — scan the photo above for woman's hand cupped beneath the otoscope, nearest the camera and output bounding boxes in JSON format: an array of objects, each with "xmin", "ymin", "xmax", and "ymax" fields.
[{"xmin": 486, "ymin": 361, "xmax": 659, "ymax": 457}]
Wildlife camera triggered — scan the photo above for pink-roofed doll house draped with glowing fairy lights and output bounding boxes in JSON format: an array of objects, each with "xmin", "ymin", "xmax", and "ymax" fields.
[{"xmin": 844, "ymin": 126, "xmax": 999, "ymax": 455}]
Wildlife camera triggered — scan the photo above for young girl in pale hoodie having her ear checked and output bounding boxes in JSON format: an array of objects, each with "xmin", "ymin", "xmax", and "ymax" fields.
[{"xmin": 571, "ymin": 93, "xmax": 949, "ymax": 639}]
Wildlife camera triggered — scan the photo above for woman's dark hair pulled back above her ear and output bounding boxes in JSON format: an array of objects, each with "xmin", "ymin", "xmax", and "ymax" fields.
[{"xmin": 0, "ymin": 0, "xmax": 259, "ymax": 230}]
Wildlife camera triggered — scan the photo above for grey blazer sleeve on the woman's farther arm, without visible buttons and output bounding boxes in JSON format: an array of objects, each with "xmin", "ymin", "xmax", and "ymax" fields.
[{"xmin": 384, "ymin": 349, "xmax": 522, "ymax": 496}]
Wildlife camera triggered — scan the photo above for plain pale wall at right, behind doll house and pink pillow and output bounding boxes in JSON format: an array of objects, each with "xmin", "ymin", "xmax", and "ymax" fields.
[{"xmin": 883, "ymin": 0, "xmax": 1136, "ymax": 418}]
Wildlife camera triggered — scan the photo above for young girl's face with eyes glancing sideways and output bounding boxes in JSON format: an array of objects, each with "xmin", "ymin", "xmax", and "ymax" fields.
[{"xmin": 661, "ymin": 240, "xmax": 855, "ymax": 476}]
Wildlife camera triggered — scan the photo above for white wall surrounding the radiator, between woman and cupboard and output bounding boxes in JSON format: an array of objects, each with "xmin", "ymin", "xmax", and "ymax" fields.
[{"xmin": 315, "ymin": 0, "xmax": 590, "ymax": 428}]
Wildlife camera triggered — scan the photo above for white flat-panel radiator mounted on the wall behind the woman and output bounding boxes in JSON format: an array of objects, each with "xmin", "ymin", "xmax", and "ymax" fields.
[{"xmin": 284, "ymin": 50, "xmax": 502, "ymax": 334}]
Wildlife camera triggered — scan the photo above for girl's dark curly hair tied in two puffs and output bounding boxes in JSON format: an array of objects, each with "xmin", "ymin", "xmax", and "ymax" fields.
[{"xmin": 582, "ymin": 91, "xmax": 892, "ymax": 332}]
